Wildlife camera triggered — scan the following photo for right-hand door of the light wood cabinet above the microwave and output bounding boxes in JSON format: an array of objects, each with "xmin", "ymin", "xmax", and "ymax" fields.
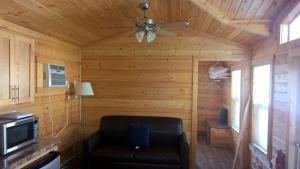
[{"xmin": 14, "ymin": 36, "xmax": 34, "ymax": 103}]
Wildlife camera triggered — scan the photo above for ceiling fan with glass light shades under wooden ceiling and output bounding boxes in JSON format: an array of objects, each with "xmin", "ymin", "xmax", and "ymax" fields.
[{"xmin": 131, "ymin": 1, "xmax": 190, "ymax": 43}]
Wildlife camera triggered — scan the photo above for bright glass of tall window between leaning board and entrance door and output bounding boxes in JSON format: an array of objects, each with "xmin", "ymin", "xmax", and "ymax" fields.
[{"xmin": 252, "ymin": 64, "xmax": 271, "ymax": 153}]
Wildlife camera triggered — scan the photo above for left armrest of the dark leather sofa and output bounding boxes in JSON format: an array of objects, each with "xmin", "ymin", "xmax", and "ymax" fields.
[{"xmin": 83, "ymin": 131, "xmax": 101, "ymax": 155}]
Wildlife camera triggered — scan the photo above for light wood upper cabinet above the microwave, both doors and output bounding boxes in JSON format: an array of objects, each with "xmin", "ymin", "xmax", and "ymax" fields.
[{"xmin": 0, "ymin": 31, "xmax": 35, "ymax": 106}]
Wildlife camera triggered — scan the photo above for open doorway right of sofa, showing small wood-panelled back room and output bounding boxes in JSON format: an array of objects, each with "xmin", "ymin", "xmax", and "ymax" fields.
[{"xmin": 196, "ymin": 61, "xmax": 234, "ymax": 169}]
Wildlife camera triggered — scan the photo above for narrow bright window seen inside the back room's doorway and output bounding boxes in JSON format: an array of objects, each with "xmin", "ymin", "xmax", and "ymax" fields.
[{"xmin": 231, "ymin": 70, "xmax": 241, "ymax": 132}]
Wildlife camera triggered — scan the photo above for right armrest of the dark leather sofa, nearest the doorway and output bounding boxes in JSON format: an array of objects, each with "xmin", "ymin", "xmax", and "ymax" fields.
[{"xmin": 179, "ymin": 133, "xmax": 190, "ymax": 169}]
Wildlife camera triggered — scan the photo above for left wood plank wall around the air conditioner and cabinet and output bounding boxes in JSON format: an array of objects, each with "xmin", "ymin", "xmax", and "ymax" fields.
[{"xmin": 0, "ymin": 20, "xmax": 80, "ymax": 159}]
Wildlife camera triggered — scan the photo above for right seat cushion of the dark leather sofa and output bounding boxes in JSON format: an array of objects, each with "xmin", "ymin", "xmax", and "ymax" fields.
[{"xmin": 134, "ymin": 147, "xmax": 180, "ymax": 164}]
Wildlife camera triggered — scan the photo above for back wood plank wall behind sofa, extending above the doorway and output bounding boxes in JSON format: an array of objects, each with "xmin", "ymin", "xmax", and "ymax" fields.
[{"xmin": 82, "ymin": 36, "xmax": 249, "ymax": 145}]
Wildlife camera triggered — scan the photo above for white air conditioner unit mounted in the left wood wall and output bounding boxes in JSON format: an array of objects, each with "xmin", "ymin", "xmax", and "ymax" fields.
[{"xmin": 43, "ymin": 64, "xmax": 66, "ymax": 87}]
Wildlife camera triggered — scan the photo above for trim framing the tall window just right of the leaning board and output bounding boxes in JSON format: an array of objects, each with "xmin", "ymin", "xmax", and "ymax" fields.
[{"xmin": 250, "ymin": 60, "xmax": 274, "ymax": 161}]
